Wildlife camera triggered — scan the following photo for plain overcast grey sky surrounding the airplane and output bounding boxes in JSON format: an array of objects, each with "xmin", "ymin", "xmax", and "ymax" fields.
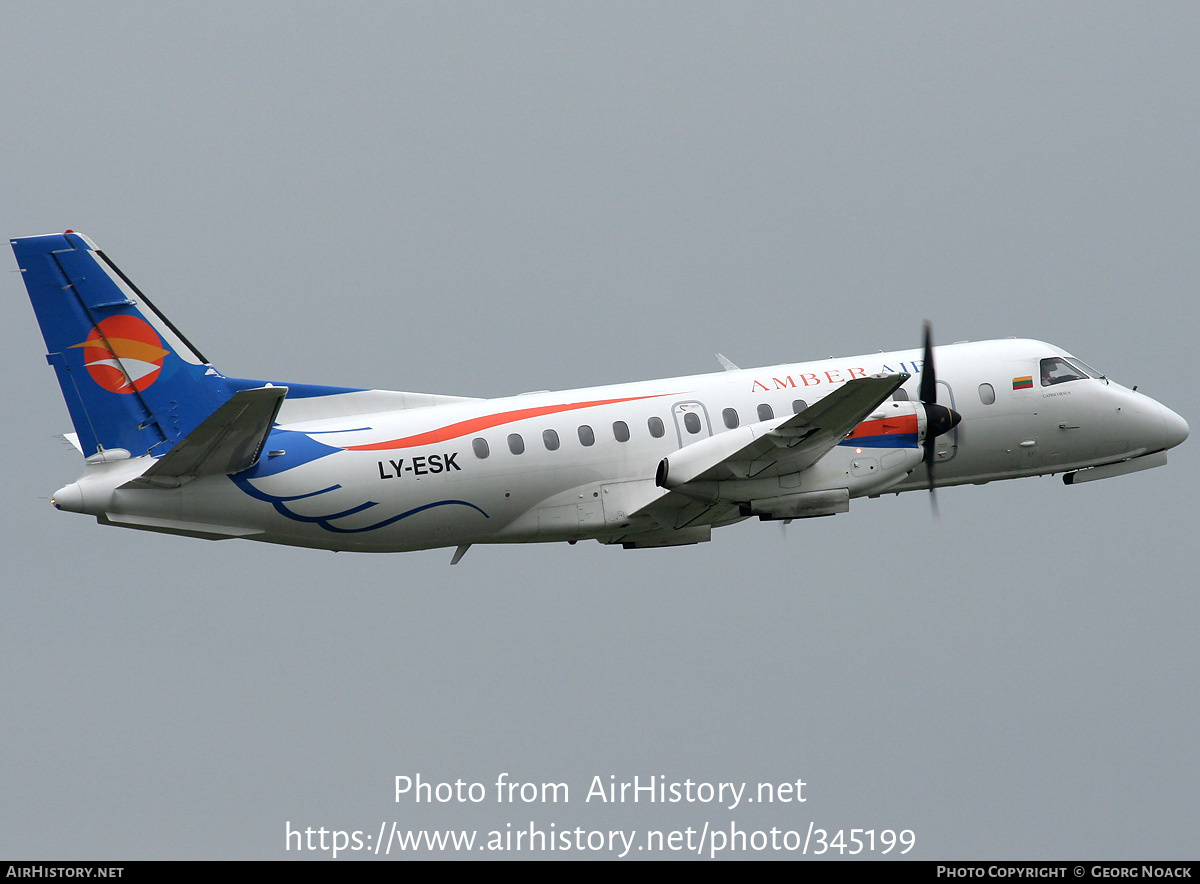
[{"xmin": 0, "ymin": 4, "xmax": 1200, "ymax": 859}]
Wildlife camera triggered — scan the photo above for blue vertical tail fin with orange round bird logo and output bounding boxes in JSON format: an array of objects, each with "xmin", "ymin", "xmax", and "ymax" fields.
[{"xmin": 11, "ymin": 230, "xmax": 234, "ymax": 457}]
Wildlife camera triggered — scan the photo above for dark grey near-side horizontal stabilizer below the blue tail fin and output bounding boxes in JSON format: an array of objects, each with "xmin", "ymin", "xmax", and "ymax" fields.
[{"xmin": 121, "ymin": 386, "xmax": 288, "ymax": 488}]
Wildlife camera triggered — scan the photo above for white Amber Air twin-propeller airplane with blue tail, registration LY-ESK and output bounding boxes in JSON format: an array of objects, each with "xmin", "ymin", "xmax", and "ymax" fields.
[{"xmin": 11, "ymin": 230, "xmax": 1188, "ymax": 564}]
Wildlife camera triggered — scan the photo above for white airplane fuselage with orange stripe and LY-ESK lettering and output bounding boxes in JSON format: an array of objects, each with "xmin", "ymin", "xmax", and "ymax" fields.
[{"xmin": 56, "ymin": 339, "xmax": 1187, "ymax": 552}]
